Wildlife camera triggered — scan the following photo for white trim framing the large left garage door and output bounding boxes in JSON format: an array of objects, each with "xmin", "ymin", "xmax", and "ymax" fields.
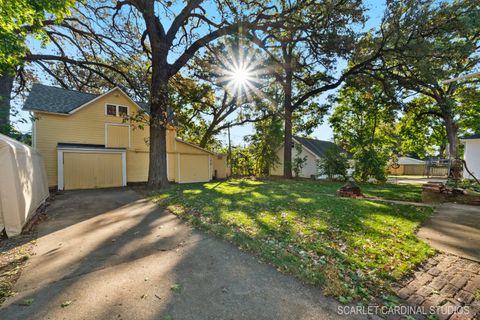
[{"xmin": 57, "ymin": 147, "xmax": 127, "ymax": 190}]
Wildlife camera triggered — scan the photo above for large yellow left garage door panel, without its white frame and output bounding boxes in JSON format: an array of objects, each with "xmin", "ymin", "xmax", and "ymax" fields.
[{"xmin": 63, "ymin": 152, "xmax": 122, "ymax": 190}]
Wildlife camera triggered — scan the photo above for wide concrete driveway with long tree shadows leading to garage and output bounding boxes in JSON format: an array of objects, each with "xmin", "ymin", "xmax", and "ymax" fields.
[{"xmin": 0, "ymin": 189, "xmax": 365, "ymax": 320}]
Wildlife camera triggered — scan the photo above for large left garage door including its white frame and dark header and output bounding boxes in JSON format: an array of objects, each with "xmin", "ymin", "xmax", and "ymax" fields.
[{"xmin": 57, "ymin": 143, "xmax": 127, "ymax": 190}]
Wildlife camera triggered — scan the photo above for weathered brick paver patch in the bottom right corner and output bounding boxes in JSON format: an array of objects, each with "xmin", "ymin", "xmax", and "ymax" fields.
[{"xmin": 394, "ymin": 253, "xmax": 480, "ymax": 320}]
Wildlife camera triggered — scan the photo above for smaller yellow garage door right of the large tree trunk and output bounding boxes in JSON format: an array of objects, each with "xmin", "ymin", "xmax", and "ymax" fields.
[{"xmin": 179, "ymin": 154, "xmax": 210, "ymax": 182}]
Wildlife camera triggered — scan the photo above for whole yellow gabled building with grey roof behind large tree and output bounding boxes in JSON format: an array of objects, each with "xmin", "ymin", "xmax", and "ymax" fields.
[{"xmin": 23, "ymin": 84, "xmax": 227, "ymax": 190}]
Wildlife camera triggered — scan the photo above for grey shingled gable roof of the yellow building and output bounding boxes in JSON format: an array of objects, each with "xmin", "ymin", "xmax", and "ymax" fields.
[{"xmin": 22, "ymin": 83, "xmax": 177, "ymax": 125}]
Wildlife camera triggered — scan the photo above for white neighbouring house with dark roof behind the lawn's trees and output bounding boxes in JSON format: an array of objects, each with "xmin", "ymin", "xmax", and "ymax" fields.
[{"xmin": 270, "ymin": 137, "xmax": 348, "ymax": 178}]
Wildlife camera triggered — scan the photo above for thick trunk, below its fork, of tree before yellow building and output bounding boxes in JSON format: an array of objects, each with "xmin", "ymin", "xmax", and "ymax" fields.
[{"xmin": 148, "ymin": 69, "xmax": 169, "ymax": 189}]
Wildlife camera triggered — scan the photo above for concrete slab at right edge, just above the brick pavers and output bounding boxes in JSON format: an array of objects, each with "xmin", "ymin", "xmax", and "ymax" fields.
[{"xmin": 418, "ymin": 203, "xmax": 480, "ymax": 262}]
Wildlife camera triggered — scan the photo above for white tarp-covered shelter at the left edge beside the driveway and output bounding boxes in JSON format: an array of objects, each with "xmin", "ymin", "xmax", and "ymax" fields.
[{"xmin": 0, "ymin": 134, "xmax": 49, "ymax": 237}]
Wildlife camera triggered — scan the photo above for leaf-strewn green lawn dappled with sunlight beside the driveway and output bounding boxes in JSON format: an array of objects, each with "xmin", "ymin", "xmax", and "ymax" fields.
[{"xmin": 152, "ymin": 180, "xmax": 433, "ymax": 301}]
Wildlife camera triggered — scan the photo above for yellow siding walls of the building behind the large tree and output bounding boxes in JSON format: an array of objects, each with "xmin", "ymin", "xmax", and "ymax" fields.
[{"xmin": 34, "ymin": 90, "xmax": 214, "ymax": 187}]
